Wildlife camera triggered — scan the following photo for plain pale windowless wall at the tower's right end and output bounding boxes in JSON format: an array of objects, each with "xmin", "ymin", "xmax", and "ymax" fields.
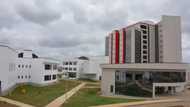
[{"xmin": 159, "ymin": 16, "xmax": 182, "ymax": 62}]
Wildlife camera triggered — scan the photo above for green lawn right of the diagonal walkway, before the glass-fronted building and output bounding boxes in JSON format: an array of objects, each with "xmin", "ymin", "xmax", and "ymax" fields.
[{"xmin": 62, "ymin": 88, "xmax": 140, "ymax": 107}]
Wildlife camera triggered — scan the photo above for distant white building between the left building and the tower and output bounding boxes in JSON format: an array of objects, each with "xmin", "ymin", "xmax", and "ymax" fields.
[{"xmin": 63, "ymin": 56, "xmax": 108, "ymax": 80}]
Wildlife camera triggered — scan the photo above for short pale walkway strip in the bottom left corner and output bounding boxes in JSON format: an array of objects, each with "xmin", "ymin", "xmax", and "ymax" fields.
[{"xmin": 0, "ymin": 97, "xmax": 34, "ymax": 107}]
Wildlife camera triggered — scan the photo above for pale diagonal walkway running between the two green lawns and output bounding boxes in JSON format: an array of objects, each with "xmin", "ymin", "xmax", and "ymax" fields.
[{"xmin": 46, "ymin": 82, "xmax": 86, "ymax": 107}]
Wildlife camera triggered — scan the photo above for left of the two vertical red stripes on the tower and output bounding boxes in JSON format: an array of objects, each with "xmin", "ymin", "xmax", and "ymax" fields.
[{"xmin": 115, "ymin": 31, "xmax": 119, "ymax": 64}]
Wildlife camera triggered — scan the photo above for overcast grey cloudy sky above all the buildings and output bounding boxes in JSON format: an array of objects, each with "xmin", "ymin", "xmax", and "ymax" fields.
[{"xmin": 0, "ymin": 0, "xmax": 190, "ymax": 62}]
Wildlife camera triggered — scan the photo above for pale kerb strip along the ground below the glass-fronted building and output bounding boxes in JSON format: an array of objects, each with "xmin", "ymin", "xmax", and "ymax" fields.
[{"xmin": 91, "ymin": 99, "xmax": 182, "ymax": 107}]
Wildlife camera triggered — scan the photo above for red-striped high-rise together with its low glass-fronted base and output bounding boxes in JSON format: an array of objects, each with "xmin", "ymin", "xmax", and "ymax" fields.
[{"xmin": 102, "ymin": 15, "xmax": 187, "ymax": 97}]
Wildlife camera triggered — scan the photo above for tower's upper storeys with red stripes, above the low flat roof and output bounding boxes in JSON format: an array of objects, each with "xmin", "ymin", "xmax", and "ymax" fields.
[{"xmin": 106, "ymin": 16, "xmax": 182, "ymax": 64}]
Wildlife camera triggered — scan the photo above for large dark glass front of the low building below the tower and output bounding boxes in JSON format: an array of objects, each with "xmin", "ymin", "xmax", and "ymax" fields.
[{"xmin": 115, "ymin": 70, "xmax": 186, "ymax": 97}]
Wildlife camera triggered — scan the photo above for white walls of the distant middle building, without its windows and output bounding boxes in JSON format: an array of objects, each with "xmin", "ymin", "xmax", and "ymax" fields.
[{"xmin": 63, "ymin": 56, "xmax": 109, "ymax": 80}]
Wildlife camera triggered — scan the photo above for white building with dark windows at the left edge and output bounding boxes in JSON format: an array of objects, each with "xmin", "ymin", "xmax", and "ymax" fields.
[{"xmin": 0, "ymin": 45, "xmax": 59, "ymax": 94}]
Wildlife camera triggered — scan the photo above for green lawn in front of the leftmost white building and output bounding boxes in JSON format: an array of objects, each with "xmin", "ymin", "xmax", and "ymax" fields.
[{"xmin": 5, "ymin": 80, "xmax": 80, "ymax": 107}]
